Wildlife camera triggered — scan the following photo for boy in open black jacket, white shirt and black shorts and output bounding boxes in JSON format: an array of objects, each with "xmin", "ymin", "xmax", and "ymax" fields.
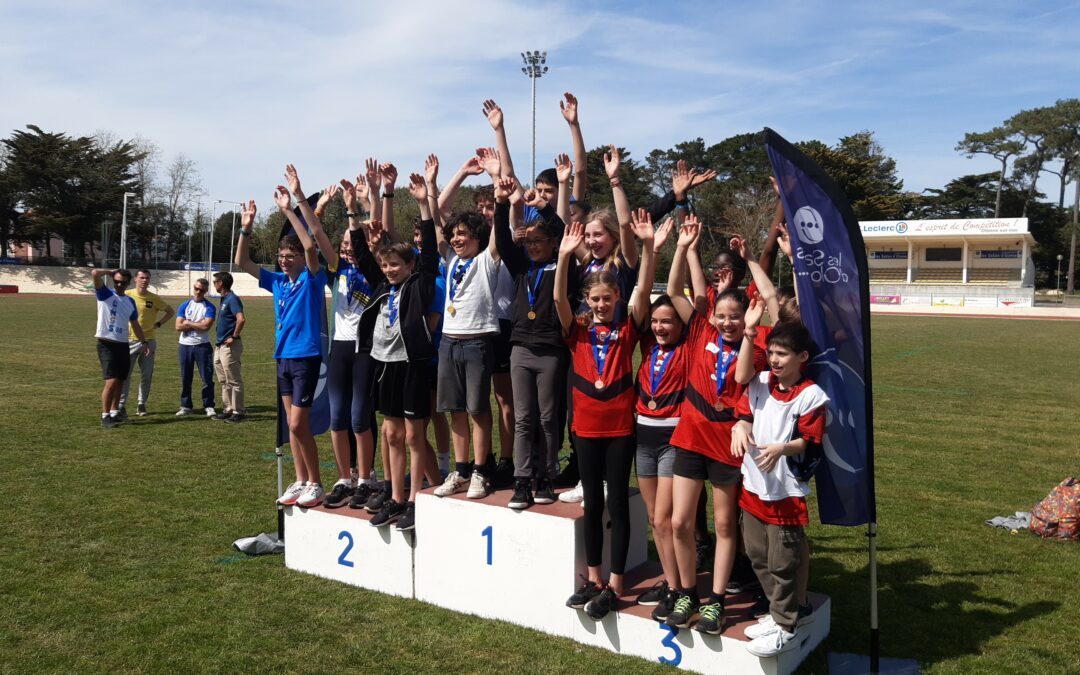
[{"xmin": 354, "ymin": 174, "xmax": 438, "ymax": 530}]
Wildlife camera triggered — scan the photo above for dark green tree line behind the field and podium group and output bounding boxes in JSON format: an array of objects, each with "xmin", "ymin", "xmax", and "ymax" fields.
[{"xmin": 0, "ymin": 99, "xmax": 1080, "ymax": 291}]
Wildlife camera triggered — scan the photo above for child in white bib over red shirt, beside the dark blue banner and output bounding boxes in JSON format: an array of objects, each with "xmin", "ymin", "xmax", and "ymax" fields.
[{"xmin": 731, "ymin": 317, "xmax": 828, "ymax": 658}]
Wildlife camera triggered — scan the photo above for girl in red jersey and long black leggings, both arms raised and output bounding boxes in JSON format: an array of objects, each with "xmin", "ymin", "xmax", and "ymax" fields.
[{"xmin": 554, "ymin": 210, "xmax": 656, "ymax": 621}]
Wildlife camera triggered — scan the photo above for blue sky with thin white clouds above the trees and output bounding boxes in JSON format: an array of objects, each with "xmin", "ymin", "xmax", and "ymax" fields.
[{"xmin": 0, "ymin": 0, "xmax": 1080, "ymax": 213}]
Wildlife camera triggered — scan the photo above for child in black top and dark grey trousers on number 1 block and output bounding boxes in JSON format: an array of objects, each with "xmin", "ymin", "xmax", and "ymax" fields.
[{"xmin": 495, "ymin": 170, "xmax": 577, "ymax": 510}]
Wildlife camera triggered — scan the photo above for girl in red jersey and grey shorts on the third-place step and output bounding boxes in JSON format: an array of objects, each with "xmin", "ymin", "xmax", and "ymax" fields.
[{"xmin": 635, "ymin": 291, "xmax": 689, "ymax": 621}]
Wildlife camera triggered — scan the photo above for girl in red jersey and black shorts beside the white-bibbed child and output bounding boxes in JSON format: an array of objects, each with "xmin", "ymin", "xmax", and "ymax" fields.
[{"xmin": 666, "ymin": 216, "xmax": 765, "ymax": 634}]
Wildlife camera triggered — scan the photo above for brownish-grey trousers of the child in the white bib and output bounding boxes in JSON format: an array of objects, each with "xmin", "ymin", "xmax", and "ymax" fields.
[{"xmin": 742, "ymin": 511, "xmax": 810, "ymax": 632}]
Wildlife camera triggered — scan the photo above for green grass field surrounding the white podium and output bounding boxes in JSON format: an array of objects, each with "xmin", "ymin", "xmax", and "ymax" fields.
[{"xmin": 0, "ymin": 295, "xmax": 1080, "ymax": 673}]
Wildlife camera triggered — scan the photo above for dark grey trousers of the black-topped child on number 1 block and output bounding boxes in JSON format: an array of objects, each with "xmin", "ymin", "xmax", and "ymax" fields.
[{"xmin": 510, "ymin": 345, "xmax": 569, "ymax": 478}]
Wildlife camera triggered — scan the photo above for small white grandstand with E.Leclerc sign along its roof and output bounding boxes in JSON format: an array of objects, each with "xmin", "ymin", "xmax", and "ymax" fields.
[{"xmin": 859, "ymin": 218, "xmax": 1035, "ymax": 308}]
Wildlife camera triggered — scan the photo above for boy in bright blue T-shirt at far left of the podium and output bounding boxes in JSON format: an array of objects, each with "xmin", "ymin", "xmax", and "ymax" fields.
[{"xmin": 235, "ymin": 164, "xmax": 336, "ymax": 508}]
